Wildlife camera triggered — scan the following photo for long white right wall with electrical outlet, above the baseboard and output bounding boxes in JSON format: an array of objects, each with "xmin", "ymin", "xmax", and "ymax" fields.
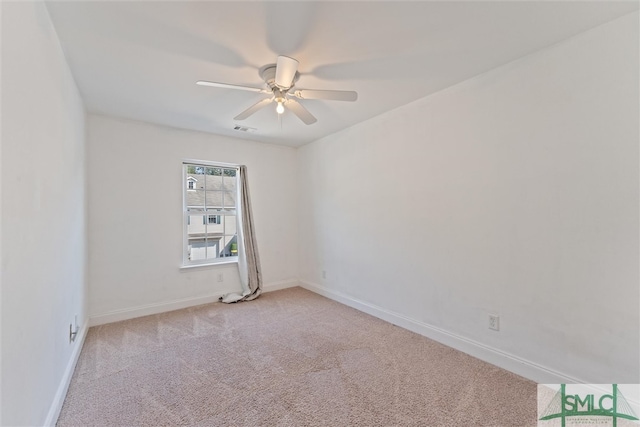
[{"xmin": 298, "ymin": 13, "xmax": 640, "ymax": 383}]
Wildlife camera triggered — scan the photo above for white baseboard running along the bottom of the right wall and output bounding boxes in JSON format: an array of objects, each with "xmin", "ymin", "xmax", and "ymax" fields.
[{"xmin": 299, "ymin": 281, "xmax": 585, "ymax": 384}]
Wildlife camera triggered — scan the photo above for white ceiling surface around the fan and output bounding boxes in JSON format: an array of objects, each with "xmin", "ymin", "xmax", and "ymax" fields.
[{"xmin": 48, "ymin": 1, "xmax": 638, "ymax": 147}]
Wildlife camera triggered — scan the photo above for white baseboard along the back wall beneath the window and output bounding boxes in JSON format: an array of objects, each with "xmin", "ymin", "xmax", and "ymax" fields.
[{"xmin": 89, "ymin": 280, "xmax": 300, "ymax": 326}]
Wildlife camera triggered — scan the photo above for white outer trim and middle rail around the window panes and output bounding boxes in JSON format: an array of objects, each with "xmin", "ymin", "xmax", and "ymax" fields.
[{"xmin": 180, "ymin": 159, "xmax": 240, "ymax": 269}]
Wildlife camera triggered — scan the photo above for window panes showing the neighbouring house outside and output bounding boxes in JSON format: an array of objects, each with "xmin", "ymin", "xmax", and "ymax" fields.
[{"xmin": 183, "ymin": 162, "xmax": 238, "ymax": 265}]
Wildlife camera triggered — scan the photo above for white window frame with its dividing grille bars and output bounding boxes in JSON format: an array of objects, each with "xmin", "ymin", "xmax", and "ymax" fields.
[{"xmin": 181, "ymin": 159, "xmax": 240, "ymax": 268}]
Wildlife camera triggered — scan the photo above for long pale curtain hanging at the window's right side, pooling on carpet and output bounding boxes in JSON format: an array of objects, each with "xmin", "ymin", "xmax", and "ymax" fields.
[{"xmin": 220, "ymin": 166, "xmax": 262, "ymax": 303}]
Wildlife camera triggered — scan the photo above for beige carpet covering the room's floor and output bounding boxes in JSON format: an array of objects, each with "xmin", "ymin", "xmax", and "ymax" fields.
[{"xmin": 58, "ymin": 288, "xmax": 536, "ymax": 426}]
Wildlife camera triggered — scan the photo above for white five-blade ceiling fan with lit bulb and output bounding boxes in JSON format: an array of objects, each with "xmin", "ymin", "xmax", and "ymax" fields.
[{"xmin": 196, "ymin": 55, "xmax": 358, "ymax": 125}]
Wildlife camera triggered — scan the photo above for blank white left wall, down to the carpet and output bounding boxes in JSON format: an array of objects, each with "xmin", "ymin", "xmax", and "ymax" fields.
[{"xmin": 0, "ymin": 2, "xmax": 87, "ymax": 426}]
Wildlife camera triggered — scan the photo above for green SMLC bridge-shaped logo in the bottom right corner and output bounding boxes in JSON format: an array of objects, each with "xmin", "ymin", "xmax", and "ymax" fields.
[{"xmin": 540, "ymin": 384, "xmax": 638, "ymax": 427}]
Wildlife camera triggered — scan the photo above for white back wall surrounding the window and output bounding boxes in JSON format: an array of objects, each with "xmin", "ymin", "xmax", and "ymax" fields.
[{"xmin": 87, "ymin": 115, "xmax": 298, "ymax": 324}]
